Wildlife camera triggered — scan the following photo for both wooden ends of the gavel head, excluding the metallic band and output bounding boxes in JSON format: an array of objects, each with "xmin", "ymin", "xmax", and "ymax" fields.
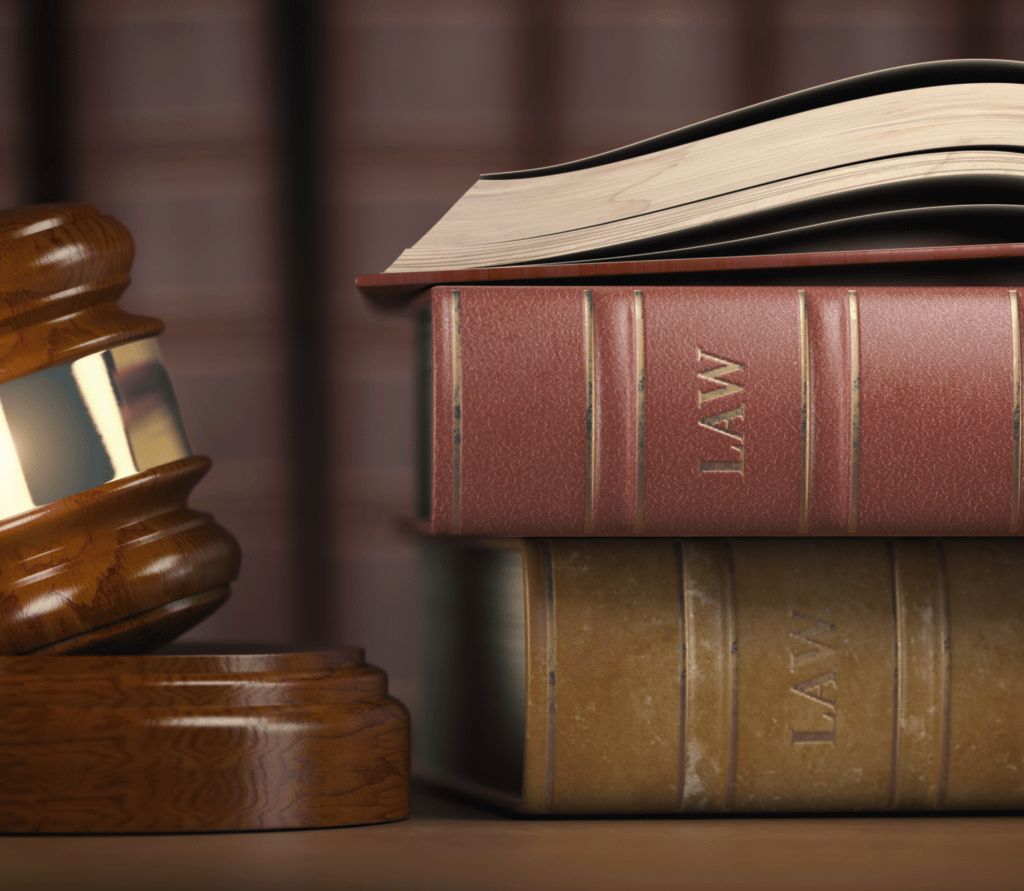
[{"xmin": 0, "ymin": 204, "xmax": 240, "ymax": 655}]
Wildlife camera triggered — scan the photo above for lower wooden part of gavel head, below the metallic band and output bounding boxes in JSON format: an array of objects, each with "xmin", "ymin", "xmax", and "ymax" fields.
[{"xmin": 0, "ymin": 457, "xmax": 240, "ymax": 655}]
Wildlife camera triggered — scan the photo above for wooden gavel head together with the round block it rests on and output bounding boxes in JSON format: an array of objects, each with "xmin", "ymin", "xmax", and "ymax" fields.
[{"xmin": 0, "ymin": 205, "xmax": 409, "ymax": 833}]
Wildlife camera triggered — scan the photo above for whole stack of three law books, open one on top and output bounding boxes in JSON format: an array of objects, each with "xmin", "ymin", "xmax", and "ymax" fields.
[{"xmin": 356, "ymin": 60, "xmax": 1024, "ymax": 813}]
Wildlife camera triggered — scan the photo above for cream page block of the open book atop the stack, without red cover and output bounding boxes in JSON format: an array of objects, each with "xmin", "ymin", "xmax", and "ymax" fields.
[{"xmin": 387, "ymin": 59, "xmax": 1024, "ymax": 272}]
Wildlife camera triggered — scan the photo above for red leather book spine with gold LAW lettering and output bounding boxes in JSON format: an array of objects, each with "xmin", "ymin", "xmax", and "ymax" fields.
[{"xmin": 431, "ymin": 286, "xmax": 1021, "ymax": 536}]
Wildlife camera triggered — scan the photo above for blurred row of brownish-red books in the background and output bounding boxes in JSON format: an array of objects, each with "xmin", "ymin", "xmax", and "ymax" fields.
[{"xmin": 0, "ymin": 0, "xmax": 1024, "ymax": 714}]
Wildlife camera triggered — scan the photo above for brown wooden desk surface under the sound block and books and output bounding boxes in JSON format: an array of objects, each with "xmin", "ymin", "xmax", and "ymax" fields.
[{"xmin": 0, "ymin": 791, "xmax": 1024, "ymax": 891}]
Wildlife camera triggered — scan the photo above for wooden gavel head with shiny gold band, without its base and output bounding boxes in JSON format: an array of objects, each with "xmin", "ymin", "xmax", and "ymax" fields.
[{"xmin": 0, "ymin": 205, "xmax": 240, "ymax": 654}]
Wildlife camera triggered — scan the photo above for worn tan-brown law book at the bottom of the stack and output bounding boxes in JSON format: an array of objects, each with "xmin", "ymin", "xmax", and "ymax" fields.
[{"xmin": 414, "ymin": 539, "xmax": 1024, "ymax": 814}]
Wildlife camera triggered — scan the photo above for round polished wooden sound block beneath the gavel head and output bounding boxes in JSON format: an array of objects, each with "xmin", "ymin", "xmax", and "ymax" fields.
[{"xmin": 0, "ymin": 648, "xmax": 409, "ymax": 833}]
